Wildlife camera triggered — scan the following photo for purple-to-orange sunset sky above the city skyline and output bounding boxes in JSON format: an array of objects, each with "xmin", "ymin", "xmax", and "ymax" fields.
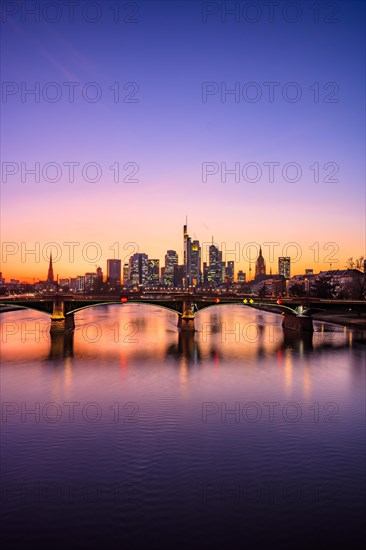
[{"xmin": 1, "ymin": 0, "xmax": 366, "ymax": 281}]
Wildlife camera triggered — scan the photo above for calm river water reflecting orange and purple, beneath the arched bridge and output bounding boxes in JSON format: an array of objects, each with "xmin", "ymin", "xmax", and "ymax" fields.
[{"xmin": 1, "ymin": 305, "xmax": 365, "ymax": 548}]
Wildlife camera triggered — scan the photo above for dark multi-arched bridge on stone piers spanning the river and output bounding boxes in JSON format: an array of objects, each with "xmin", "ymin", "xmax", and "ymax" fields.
[{"xmin": 0, "ymin": 291, "xmax": 366, "ymax": 334}]
